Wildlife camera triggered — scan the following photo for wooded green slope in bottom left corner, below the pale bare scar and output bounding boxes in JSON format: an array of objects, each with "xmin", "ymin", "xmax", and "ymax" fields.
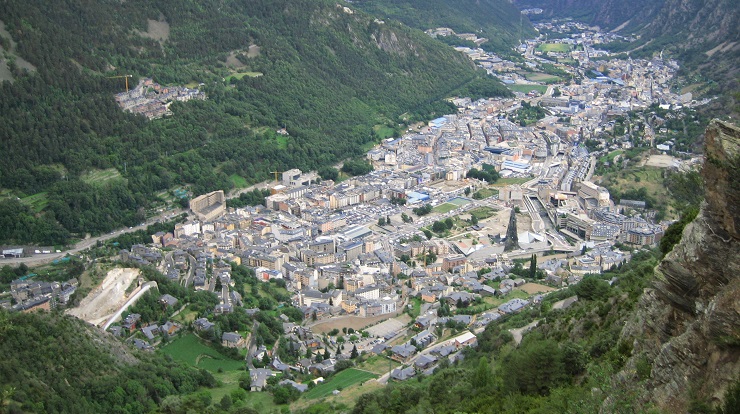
[{"xmin": 0, "ymin": 309, "xmax": 215, "ymax": 413}]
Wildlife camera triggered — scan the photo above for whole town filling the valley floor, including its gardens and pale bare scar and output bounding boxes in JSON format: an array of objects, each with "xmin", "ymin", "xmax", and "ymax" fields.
[{"xmin": 2, "ymin": 21, "xmax": 707, "ymax": 402}]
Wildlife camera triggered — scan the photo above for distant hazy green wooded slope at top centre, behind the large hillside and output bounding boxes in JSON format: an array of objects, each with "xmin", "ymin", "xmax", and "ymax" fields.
[{"xmin": 354, "ymin": 0, "xmax": 535, "ymax": 53}]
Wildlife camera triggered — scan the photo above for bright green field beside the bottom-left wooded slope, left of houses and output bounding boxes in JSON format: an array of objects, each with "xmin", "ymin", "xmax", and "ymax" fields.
[{"xmin": 161, "ymin": 334, "xmax": 244, "ymax": 372}]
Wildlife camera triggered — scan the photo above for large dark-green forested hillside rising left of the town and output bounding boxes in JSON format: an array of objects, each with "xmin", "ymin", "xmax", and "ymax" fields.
[{"xmin": 0, "ymin": 0, "xmax": 509, "ymax": 243}]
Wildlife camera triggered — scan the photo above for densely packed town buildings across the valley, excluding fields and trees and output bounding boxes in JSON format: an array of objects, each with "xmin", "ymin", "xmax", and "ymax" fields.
[{"xmin": 3, "ymin": 18, "xmax": 686, "ymax": 391}]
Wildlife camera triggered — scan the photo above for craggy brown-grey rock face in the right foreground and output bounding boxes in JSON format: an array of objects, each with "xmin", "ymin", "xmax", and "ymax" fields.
[{"xmin": 615, "ymin": 121, "xmax": 740, "ymax": 412}]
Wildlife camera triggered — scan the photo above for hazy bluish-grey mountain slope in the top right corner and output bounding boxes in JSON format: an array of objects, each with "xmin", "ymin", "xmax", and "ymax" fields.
[{"xmin": 515, "ymin": 0, "xmax": 740, "ymax": 102}]
